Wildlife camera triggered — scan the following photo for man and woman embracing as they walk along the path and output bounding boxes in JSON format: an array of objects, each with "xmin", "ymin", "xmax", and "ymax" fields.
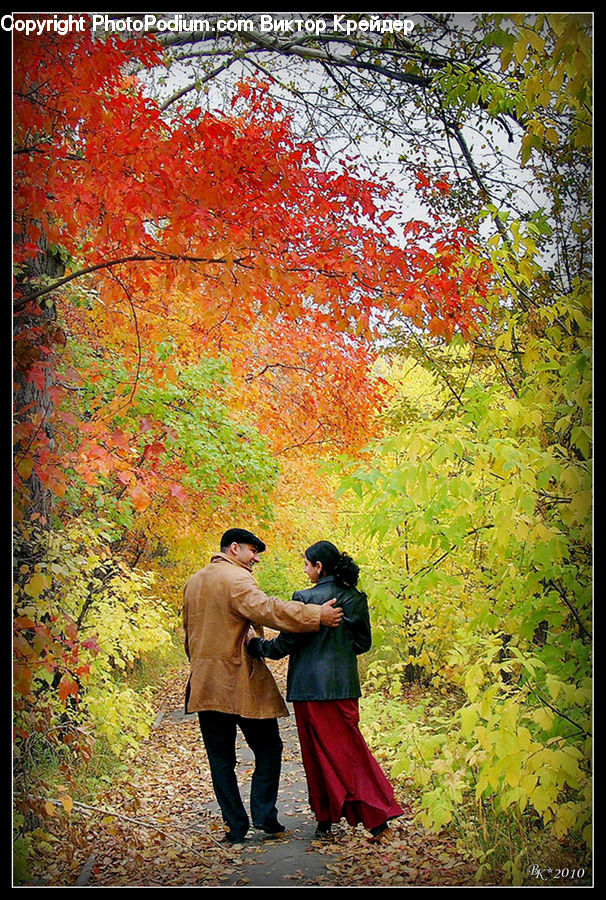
[{"xmin": 183, "ymin": 528, "xmax": 403, "ymax": 843}]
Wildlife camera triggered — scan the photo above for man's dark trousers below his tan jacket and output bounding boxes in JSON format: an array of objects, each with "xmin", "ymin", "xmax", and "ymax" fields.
[{"xmin": 198, "ymin": 711, "xmax": 282, "ymax": 839}]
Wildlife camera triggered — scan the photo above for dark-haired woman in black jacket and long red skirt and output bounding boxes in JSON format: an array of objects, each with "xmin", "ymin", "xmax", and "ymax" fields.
[{"xmin": 248, "ymin": 541, "xmax": 403, "ymax": 840}]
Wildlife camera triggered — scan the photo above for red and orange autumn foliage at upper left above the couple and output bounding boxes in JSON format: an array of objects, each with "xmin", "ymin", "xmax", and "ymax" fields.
[{"xmin": 14, "ymin": 26, "xmax": 490, "ymax": 511}]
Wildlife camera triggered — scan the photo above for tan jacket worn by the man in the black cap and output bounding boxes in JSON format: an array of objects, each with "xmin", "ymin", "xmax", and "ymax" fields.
[{"xmin": 183, "ymin": 553, "xmax": 321, "ymax": 719}]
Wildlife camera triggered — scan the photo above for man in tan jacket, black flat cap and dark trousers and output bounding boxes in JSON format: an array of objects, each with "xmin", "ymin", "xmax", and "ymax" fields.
[{"xmin": 183, "ymin": 528, "xmax": 343, "ymax": 843}]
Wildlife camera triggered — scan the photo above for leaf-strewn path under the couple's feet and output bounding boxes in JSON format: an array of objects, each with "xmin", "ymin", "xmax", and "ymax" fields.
[{"xmin": 26, "ymin": 661, "xmax": 474, "ymax": 887}]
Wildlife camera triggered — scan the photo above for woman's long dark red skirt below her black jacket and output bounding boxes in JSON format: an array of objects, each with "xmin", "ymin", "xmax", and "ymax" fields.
[{"xmin": 293, "ymin": 699, "xmax": 404, "ymax": 830}]
